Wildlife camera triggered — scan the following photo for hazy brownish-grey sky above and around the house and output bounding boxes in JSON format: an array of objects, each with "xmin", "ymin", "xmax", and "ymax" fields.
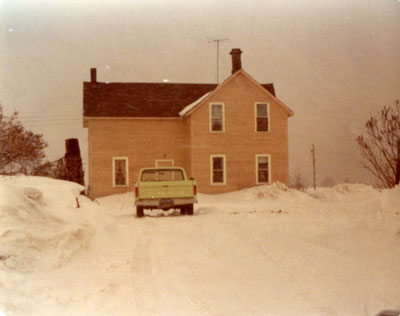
[{"xmin": 0, "ymin": 0, "xmax": 400, "ymax": 184}]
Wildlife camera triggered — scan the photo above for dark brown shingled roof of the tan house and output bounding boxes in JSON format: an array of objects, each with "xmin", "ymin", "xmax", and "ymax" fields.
[{"xmin": 83, "ymin": 82, "xmax": 275, "ymax": 117}]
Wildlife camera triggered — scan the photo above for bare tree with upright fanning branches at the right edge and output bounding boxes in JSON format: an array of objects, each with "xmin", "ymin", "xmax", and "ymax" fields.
[{"xmin": 357, "ymin": 101, "xmax": 400, "ymax": 188}]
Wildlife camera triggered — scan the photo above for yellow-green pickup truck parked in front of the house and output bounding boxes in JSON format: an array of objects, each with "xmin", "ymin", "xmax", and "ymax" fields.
[{"xmin": 135, "ymin": 167, "xmax": 197, "ymax": 217}]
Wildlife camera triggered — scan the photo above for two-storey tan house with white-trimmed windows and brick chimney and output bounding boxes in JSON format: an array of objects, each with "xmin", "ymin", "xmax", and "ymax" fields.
[{"xmin": 83, "ymin": 49, "xmax": 293, "ymax": 197}]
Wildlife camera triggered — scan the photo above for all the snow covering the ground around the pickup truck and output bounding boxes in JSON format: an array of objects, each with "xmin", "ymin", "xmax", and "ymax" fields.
[{"xmin": 0, "ymin": 176, "xmax": 400, "ymax": 316}]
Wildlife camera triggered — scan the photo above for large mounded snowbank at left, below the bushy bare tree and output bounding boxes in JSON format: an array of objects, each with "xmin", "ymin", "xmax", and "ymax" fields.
[{"xmin": 0, "ymin": 176, "xmax": 94, "ymax": 272}]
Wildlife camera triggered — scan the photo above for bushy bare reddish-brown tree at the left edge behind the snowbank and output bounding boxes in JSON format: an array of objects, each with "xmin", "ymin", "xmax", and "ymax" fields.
[{"xmin": 0, "ymin": 104, "xmax": 48, "ymax": 174}]
